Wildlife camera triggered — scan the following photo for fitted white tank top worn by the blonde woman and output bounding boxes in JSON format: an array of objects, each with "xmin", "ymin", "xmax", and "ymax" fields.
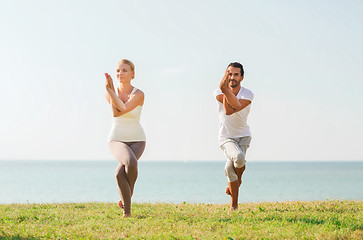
[{"xmin": 109, "ymin": 87, "xmax": 146, "ymax": 142}]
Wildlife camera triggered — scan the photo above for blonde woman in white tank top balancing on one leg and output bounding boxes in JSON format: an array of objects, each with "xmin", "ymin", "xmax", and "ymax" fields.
[{"xmin": 105, "ymin": 59, "xmax": 146, "ymax": 217}]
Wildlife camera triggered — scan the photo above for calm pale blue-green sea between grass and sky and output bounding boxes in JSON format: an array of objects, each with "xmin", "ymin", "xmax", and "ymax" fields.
[{"xmin": 0, "ymin": 160, "xmax": 363, "ymax": 204}]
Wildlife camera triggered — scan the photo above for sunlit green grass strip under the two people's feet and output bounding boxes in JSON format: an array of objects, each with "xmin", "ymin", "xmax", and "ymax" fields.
[{"xmin": 0, "ymin": 200, "xmax": 363, "ymax": 239}]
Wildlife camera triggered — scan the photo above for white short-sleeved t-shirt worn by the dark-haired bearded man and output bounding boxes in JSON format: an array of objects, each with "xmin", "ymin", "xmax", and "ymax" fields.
[{"xmin": 214, "ymin": 87, "xmax": 253, "ymax": 140}]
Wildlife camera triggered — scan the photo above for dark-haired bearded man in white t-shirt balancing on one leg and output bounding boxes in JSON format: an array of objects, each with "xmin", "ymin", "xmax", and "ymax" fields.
[{"xmin": 215, "ymin": 62, "xmax": 253, "ymax": 210}]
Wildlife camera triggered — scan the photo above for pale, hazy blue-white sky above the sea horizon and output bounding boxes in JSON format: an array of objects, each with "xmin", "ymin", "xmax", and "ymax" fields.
[{"xmin": 0, "ymin": 0, "xmax": 363, "ymax": 161}]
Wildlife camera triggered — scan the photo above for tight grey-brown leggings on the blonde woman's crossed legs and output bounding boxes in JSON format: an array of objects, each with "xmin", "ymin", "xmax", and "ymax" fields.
[{"xmin": 109, "ymin": 141, "xmax": 146, "ymax": 214}]
